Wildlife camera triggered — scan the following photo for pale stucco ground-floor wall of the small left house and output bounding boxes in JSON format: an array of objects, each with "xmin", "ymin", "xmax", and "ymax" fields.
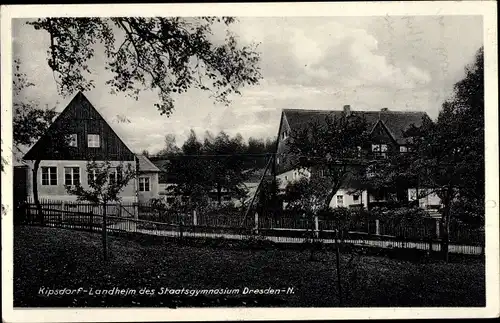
[{"xmin": 27, "ymin": 160, "xmax": 137, "ymax": 202}]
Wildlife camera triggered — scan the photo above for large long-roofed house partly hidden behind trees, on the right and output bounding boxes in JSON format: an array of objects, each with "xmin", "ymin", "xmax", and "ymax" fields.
[{"xmin": 274, "ymin": 105, "xmax": 440, "ymax": 208}]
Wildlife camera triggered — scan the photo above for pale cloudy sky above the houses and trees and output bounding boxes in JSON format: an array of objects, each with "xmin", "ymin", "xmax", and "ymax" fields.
[{"xmin": 13, "ymin": 16, "xmax": 483, "ymax": 153}]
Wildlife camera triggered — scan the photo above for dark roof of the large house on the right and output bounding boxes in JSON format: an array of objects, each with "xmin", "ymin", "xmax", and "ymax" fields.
[{"xmin": 283, "ymin": 109, "xmax": 430, "ymax": 143}]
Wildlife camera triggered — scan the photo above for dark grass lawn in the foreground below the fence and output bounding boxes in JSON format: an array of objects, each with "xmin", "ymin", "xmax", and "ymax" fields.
[{"xmin": 14, "ymin": 226, "xmax": 485, "ymax": 307}]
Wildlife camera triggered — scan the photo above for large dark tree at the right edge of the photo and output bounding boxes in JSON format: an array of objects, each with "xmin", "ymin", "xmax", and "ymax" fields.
[{"xmin": 372, "ymin": 48, "xmax": 484, "ymax": 261}]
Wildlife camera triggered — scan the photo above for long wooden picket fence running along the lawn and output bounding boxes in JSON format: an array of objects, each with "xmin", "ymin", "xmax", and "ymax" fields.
[{"xmin": 16, "ymin": 201, "xmax": 484, "ymax": 254}]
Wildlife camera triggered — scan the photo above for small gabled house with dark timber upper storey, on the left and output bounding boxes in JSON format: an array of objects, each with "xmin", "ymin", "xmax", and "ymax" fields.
[{"xmin": 23, "ymin": 92, "xmax": 138, "ymax": 203}]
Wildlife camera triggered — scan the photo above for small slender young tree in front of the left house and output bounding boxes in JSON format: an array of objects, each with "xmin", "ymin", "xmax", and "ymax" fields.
[{"xmin": 65, "ymin": 161, "xmax": 136, "ymax": 261}]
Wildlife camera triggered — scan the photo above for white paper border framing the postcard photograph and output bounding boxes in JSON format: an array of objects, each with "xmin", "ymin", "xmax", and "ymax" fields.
[{"xmin": 1, "ymin": 1, "xmax": 500, "ymax": 322}]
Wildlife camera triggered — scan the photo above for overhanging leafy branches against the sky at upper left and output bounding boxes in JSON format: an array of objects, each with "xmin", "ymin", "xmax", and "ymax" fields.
[{"xmin": 28, "ymin": 17, "xmax": 261, "ymax": 115}]
